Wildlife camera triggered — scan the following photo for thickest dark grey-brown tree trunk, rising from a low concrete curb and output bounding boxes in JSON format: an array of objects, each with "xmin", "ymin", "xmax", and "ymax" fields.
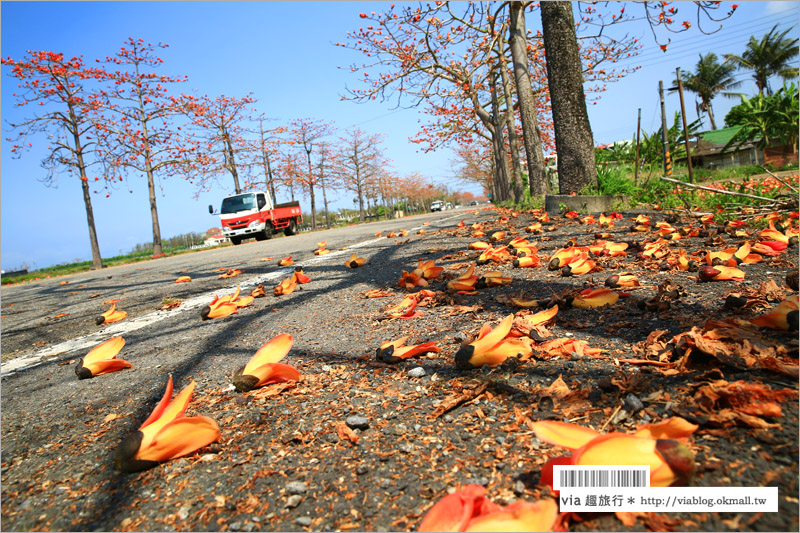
[{"xmin": 540, "ymin": 1, "xmax": 597, "ymax": 194}]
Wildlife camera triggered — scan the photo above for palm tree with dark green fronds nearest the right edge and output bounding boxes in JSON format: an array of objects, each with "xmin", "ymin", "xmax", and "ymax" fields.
[{"xmin": 725, "ymin": 24, "xmax": 798, "ymax": 96}]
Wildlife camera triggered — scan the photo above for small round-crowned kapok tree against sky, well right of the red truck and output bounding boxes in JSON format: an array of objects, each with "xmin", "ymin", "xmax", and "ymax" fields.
[{"xmin": 336, "ymin": 127, "xmax": 386, "ymax": 222}]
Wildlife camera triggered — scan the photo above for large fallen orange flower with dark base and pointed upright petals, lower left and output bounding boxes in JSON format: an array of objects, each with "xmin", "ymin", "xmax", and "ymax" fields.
[{"xmin": 114, "ymin": 376, "xmax": 220, "ymax": 472}]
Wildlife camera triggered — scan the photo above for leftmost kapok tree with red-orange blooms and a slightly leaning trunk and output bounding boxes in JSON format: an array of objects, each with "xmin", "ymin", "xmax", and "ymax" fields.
[{"xmin": 2, "ymin": 51, "xmax": 108, "ymax": 269}]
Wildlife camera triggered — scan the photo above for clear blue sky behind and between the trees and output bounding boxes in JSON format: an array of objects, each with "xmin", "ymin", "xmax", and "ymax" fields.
[{"xmin": 0, "ymin": 1, "xmax": 798, "ymax": 270}]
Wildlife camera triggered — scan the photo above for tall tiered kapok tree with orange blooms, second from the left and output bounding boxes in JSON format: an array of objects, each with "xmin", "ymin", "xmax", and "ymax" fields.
[{"xmin": 97, "ymin": 37, "xmax": 198, "ymax": 257}]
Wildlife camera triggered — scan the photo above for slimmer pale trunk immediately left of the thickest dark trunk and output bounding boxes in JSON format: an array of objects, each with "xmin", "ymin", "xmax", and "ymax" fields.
[{"xmin": 509, "ymin": 2, "xmax": 547, "ymax": 196}]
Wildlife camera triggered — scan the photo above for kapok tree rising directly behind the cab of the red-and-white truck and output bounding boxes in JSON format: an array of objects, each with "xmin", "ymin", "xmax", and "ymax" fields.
[{"xmin": 190, "ymin": 93, "xmax": 256, "ymax": 194}]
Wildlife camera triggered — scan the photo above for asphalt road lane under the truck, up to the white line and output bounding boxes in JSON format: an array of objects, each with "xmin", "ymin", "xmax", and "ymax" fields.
[{"xmin": 2, "ymin": 208, "xmax": 475, "ymax": 376}]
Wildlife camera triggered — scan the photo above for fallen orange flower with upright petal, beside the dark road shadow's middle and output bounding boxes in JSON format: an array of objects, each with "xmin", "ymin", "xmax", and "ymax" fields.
[{"xmin": 233, "ymin": 333, "xmax": 300, "ymax": 392}]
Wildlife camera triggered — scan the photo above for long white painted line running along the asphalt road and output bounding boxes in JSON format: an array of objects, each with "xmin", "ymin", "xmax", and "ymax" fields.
[{"xmin": 0, "ymin": 214, "xmax": 463, "ymax": 376}]
